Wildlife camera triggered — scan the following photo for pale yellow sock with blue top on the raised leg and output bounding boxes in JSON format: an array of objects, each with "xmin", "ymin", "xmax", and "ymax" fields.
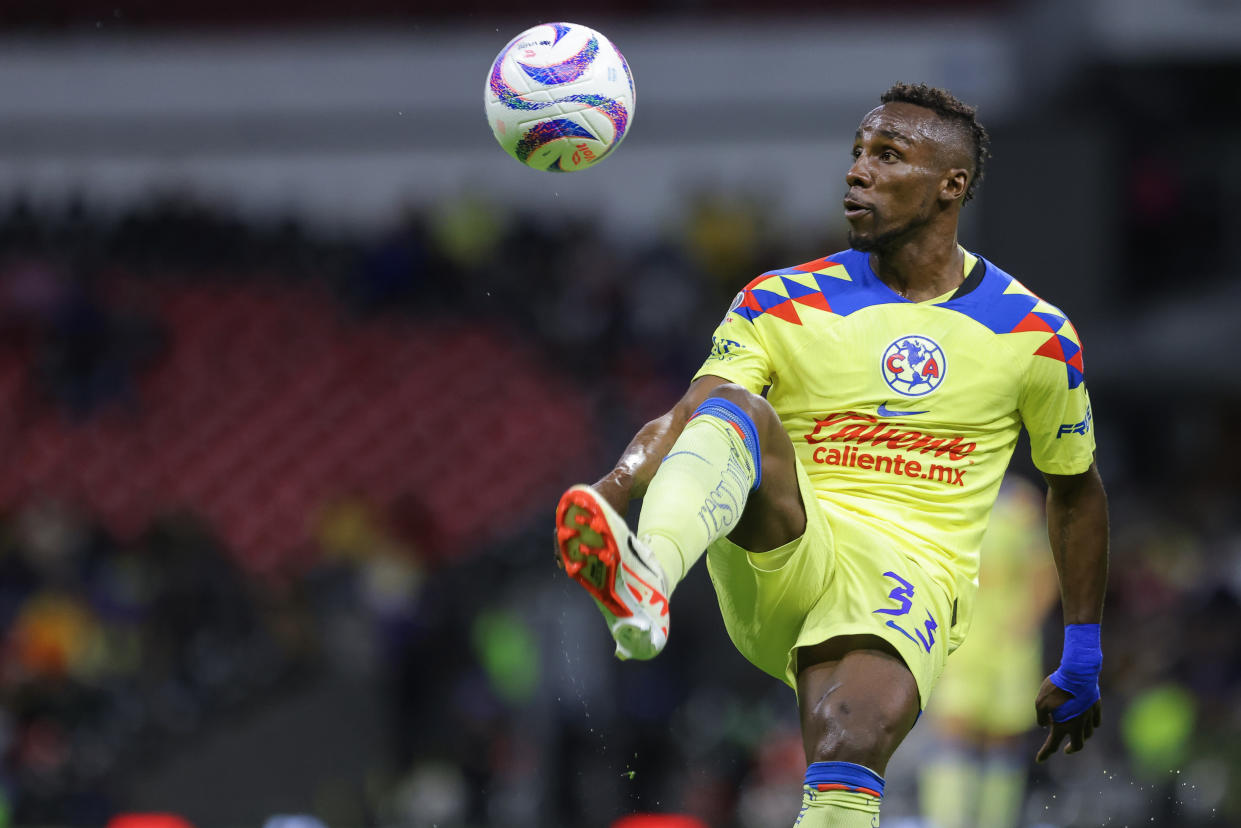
[{"xmin": 638, "ymin": 397, "xmax": 761, "ymax": 595}]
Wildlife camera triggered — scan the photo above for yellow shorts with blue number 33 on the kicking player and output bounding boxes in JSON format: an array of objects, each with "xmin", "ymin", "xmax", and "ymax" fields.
[{"xmin": 706, "ymin": 463, "xmax": 953, "ymax": 708}]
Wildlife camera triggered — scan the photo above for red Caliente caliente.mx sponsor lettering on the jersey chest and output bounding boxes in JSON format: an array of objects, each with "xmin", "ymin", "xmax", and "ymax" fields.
[{"xmin": 805, "ymin": 411, "xmax": 978, "ymax": 487}]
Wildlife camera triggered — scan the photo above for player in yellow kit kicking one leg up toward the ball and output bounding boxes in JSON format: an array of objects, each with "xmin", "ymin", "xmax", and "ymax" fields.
[{"xmin": 556, "ymin": 84, "xmax": 1107, "ymax": 828}]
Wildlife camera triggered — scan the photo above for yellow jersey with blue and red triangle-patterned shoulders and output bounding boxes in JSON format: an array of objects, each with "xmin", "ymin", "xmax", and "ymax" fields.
[{"xmin": 695, "ymin": 250, "xmax": 1095, "ymax": 648}]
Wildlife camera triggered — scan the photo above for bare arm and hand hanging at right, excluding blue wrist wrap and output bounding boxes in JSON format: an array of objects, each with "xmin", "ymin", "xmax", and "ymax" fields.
[{"xmin": 1035, "ymin": 464, "xmax": 1108, "ymax": 762}]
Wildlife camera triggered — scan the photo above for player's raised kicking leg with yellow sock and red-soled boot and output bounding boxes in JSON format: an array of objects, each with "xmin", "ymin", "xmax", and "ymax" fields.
[{"xmin": 556, "ymin": 384, "xmax": 805, "ymax": 658}]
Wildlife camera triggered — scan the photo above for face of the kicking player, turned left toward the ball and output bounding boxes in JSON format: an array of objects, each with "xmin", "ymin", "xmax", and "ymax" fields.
[{"xmin": 844, "ymin": 103, "xmax": 946, "ymax": 251}]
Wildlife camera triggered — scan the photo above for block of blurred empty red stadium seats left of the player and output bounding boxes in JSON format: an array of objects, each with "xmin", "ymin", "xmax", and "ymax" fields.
[{"xmin": 0, "ymin": 286, "xmax": 592, "ymax": 570}]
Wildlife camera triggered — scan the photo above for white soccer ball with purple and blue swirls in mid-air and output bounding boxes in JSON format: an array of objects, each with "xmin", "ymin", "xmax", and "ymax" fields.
[{"xmin": 485, "ymin": 24, "xmax": 634, "ymax": 173}]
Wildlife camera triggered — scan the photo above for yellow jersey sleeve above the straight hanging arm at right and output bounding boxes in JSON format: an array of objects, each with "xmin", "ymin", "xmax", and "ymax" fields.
[{"xmin": 1019, "ymin": 325, "xmax": 1095, "ymax": 474}]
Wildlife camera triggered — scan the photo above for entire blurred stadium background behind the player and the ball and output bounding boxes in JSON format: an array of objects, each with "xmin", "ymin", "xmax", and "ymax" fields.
[{"xmin": 0, "ymin": 0, "xmax": 1241, "ymax": 828}]
